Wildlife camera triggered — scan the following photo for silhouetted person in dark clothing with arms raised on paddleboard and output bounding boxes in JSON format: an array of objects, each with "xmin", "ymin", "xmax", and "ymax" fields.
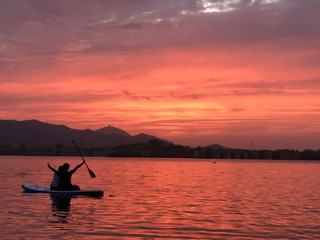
[{"xmin": 48, "ymin": 161, "xmax": 85, "ymax": 190}]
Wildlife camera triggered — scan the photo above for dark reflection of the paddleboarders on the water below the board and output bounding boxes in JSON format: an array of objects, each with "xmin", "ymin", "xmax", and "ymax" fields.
[{"xmin": 50, "ymin": 195, "xmax": 71, "ymax": 223}]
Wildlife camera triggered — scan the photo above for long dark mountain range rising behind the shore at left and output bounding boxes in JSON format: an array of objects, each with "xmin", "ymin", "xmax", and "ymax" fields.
[{"xmin": 0, "ymin": 120, "xmax": 165, "ymax": 147}]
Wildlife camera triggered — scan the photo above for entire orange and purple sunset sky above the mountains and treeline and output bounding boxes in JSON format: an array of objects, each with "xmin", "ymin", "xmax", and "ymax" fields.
[{"xmin": 0, "ymin": 0, "xmax": 320, "ymax": 150}]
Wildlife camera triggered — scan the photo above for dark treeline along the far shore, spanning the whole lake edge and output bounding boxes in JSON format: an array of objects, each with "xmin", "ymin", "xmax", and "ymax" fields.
[{"xmin": 0, "ymin": 140, "xmax": 320, "ymax": 160}]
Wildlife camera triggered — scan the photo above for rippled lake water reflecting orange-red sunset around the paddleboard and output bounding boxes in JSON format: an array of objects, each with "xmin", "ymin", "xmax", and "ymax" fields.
[{"xmin": 0, "ymin": 156, "xmax": 320, "ymax": 240}]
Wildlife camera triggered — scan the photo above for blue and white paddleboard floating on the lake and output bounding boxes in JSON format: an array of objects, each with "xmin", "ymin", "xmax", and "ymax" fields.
[{"xmin": 22, "ymin": 183, "xmax": 103, "ymax": 197}]
